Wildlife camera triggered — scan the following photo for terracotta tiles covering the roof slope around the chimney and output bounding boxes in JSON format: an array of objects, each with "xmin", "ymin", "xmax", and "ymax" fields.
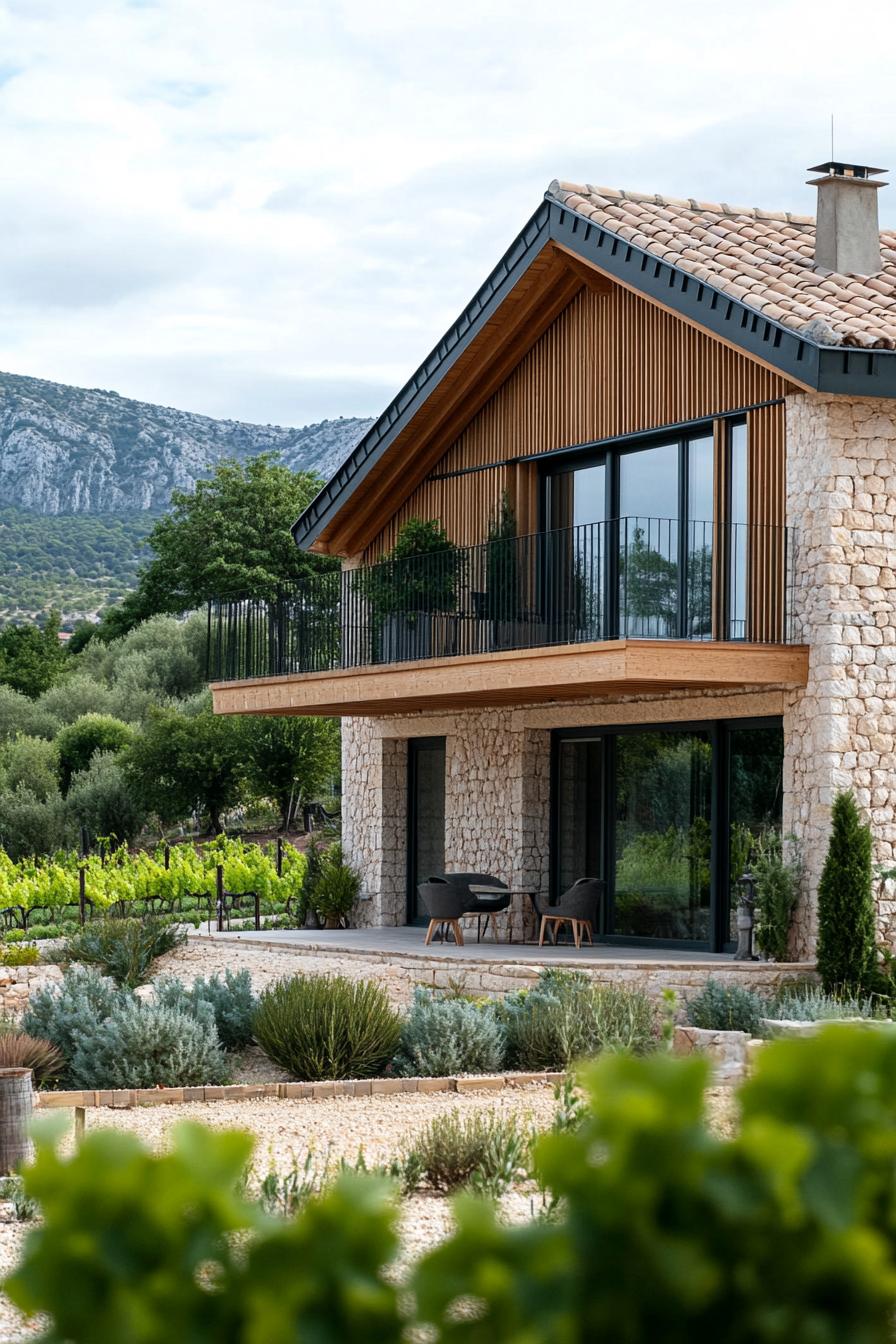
[{"xmin": 548, "ymin": 181, "xmax": 896, "ymax": 349}]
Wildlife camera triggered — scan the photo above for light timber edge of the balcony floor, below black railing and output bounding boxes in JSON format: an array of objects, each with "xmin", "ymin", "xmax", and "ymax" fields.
[{"xmin": 211, "ymin": 640, "xmax": 809, "ymax": 718}]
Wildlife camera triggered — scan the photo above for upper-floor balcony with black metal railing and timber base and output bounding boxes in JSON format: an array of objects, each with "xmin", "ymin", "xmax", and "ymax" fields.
[{"xmin": 208, "ymin": 517, "xmax": 806, "ymax": 714}]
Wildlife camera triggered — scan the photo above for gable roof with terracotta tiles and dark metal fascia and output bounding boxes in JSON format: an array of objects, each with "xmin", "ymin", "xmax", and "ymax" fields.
[{"xmin": 293, "ymin": 180, "xmax": 896, "ymax": 548}]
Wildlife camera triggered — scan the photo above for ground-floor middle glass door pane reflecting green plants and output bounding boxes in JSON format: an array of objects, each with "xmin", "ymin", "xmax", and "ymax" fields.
[{"xmin": 613, "ymin": 731, "xmax": 712, "ymax": 942}]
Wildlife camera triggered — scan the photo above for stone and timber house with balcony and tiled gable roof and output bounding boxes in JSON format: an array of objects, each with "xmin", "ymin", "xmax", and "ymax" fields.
[{"xmin": 210, "ymin": 163, "xmax": 896, "ymax": 956}]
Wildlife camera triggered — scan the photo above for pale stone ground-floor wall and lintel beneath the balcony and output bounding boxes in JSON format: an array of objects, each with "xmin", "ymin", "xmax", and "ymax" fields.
[{"xmin": 343, "ymin": 688, "xmax": 785, "ymax": 935}]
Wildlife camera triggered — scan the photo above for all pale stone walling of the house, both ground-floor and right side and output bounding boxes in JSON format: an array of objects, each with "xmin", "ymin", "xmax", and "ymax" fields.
[{"xmin": 344, "ymin": 392, "xmax": 896, "ymax": 957}]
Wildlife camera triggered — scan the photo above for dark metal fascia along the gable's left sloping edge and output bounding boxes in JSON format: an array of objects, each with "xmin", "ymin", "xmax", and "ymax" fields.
[{"xmin": 292, "ymin": 202, "xmax": 549, "ymax": 547}]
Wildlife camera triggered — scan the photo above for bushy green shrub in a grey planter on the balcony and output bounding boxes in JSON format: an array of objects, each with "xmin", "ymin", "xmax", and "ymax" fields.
[{"xmin": 355, "ymin": 517, "xmax": 465, "ymax": 663}]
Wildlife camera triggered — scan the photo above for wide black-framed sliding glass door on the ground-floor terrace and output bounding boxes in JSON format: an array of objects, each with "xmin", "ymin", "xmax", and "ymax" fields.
[{"xmin": 551, "ymin": 720, "xmax": 783, "ymax": 950}]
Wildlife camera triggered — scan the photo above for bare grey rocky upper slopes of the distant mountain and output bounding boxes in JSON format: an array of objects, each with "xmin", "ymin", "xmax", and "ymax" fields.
[{"xmin": 0, "ymin": 374, "xmax": 371, "ymax": 513}]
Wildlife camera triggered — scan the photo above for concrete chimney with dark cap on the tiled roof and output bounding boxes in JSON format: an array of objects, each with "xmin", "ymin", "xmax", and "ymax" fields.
[{"xmin": 809, "ymin": 161, "xmax": 887, "ymax": 276}]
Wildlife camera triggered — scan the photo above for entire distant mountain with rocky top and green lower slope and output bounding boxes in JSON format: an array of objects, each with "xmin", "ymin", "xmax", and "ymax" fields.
[{"xmin": 0, "ymin": 374, "xmax": 372, "ymax": 621}]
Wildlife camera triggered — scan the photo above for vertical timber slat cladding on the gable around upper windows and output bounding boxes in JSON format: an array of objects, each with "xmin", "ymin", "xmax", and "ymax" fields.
[{"xmin": 364, "ymin": 286, "xmax": 790, "ymax": 563}]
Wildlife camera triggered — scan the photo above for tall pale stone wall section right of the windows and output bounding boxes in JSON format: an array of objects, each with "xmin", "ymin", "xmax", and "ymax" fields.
[{"xmin": 785, "ymin": 394, "xmax": 896, "ymax": 954}]
